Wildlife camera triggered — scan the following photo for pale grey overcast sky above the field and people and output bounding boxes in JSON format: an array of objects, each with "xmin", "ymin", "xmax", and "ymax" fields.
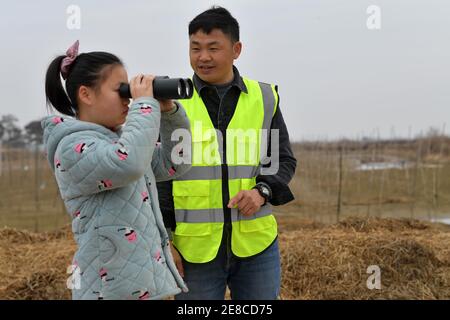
[{"xmin": 0, "ymin": 0, "xmax": 450, "ymax": 140}]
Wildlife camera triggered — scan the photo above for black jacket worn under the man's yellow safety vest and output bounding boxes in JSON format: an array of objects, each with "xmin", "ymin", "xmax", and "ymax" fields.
[{"xmin": 157, "ymin": 67, "xmax": 297, "ymax": 230}]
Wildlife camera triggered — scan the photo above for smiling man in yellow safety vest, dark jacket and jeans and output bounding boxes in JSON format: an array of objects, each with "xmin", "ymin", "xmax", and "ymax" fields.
[{"xmin": 158, "ymin": 7, "xmax": 296, "ymax": 300}]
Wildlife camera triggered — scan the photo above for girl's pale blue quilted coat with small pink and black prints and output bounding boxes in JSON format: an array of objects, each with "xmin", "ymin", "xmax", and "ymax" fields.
[{"xmin": 42, "ymin": 97, "xmax": 190, "ymax": 300}]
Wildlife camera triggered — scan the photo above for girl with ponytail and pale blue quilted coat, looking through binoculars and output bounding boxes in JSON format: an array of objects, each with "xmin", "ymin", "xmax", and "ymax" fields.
[{"xmin": 42, "ymin": 41, "xmax": 190, "ymax": 300}]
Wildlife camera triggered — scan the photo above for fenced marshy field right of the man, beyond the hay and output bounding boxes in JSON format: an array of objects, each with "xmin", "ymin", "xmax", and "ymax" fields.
[{"xmin": 284, "ymin": 137, "xmax": 450, "ymax": 221}]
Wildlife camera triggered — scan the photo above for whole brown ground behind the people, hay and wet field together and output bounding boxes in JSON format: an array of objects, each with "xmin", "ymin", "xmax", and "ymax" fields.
[{"xmin": 0, "ymin": 137, "xmax": 450, "ymax": 299}]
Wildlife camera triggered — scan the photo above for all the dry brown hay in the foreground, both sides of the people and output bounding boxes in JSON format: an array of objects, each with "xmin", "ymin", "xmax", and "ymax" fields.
[{"xmin": 0, "ymin": 217, "xmax": 450, "ymax": 299}]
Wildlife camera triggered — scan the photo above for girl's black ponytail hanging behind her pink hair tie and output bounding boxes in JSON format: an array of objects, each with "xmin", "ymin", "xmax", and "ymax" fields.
[{"xmin": 45, "ymin": 55, "xmax": 75, "ymax": 116}]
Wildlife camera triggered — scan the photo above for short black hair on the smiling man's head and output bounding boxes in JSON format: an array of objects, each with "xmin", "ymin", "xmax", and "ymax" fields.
[{"xmin": 189, "ymin": 6, "xmax": 239, "ymax": 43}]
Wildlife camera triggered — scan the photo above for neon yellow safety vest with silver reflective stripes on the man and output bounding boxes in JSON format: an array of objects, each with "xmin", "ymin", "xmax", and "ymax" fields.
[{"xmin": 172, "ymin": 79, "xmax": 278, "ymax": 263}]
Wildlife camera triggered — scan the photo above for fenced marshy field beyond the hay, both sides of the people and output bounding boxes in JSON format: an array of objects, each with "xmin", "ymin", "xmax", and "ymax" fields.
[{"xmin": 0, "ymin": 137, "xmax": 450, "ymax": 231}]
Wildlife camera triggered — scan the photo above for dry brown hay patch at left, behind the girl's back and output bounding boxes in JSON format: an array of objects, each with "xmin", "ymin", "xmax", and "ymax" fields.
[{"xmin": 0, "ymin": 227, "xmax": 76, "ymax": 300}]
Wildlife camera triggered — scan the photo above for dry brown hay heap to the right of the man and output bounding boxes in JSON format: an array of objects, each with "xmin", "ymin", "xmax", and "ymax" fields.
[{"xmin": 280, "ymin": 218, "xmax": 450, "ymax": 299}]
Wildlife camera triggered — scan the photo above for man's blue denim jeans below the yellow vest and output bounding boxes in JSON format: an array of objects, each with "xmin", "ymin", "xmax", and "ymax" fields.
[{"xmin": 175, "ymin": 235, "xmax": 281, "ymax": 300}]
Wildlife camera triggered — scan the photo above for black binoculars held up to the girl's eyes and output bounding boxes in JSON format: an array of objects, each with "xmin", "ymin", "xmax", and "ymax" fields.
[{"xmin": 119, "ymin": 76, "xmax": 194, "ymax": 100}]
